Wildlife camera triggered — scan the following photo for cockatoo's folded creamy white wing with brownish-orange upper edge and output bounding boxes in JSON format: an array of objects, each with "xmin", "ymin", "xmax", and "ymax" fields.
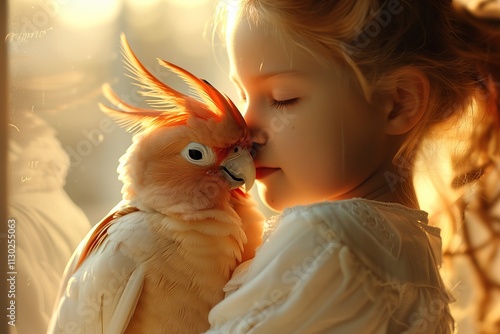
[{"xmin": 48, "ymin": 209, "xmax": 152, "ymax": 334}]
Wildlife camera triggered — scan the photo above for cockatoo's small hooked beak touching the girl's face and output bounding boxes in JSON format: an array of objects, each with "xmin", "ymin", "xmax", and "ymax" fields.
[{"xmin": 221, "ymin": 149, "xmax": 255, "ymax": 192}]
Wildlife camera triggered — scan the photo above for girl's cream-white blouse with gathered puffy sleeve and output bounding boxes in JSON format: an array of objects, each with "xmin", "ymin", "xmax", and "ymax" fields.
[{"xmin": 207, "ymin": 199, "xmax": 453, "ymax": 334}]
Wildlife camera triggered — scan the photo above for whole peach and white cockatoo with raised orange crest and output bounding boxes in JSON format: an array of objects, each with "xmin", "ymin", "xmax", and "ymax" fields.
[{"xmin": 49, "ymin": 35, "xmax": 264, "ymax": 334}]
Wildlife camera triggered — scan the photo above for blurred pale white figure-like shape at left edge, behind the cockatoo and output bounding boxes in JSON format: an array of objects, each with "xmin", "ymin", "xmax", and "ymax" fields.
[{"xmin": 8, "ymin": 112, "xmax": 90, "ymax": 334}]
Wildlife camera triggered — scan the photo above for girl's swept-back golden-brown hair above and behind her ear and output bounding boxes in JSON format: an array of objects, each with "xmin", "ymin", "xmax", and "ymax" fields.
[{"xmin": 216, "ymin": 0, "xmax": 494, "ymax": 162}]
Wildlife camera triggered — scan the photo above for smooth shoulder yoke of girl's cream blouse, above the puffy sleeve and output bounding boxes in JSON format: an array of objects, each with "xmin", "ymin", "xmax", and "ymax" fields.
[{"xmin": 264, "ymin": 198, "xmax": 442, "ymax": 286}]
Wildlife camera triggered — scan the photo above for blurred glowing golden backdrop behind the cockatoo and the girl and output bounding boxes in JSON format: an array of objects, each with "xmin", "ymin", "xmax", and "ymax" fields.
[{"xmin": 6, "ymin": 0, "xmax": 500, "ymax": 334}]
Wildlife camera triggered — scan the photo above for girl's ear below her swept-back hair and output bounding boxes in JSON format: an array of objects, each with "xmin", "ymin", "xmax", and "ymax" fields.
[{"xmin": 383, "ymin": 66, "xmax": 430, "ymax": 135}]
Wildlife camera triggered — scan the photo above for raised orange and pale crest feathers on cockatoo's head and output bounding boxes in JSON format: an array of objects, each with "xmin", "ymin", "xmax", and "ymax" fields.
[{"xmin": 99, "ymin": 34, "xmax": 245, "ymax": 131}]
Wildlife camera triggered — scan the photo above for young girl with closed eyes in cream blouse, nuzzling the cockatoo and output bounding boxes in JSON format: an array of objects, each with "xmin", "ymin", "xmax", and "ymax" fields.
[{"xmin": 205, "ymin": 0, "xmax": 498, "ymax": 333}]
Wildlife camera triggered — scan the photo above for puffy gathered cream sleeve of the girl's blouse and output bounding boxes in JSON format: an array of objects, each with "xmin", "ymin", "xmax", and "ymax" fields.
[{"xmin": 207, "ymin": 200, "xmax": 451, "ymax": 333}]
